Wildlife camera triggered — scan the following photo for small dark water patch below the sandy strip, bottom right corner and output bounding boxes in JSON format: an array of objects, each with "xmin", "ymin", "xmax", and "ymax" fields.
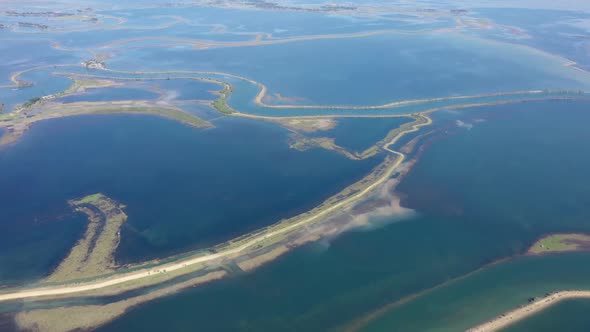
[{"xmin": 502, "ymin": 299, "xmax": 590, "ymax": 332}]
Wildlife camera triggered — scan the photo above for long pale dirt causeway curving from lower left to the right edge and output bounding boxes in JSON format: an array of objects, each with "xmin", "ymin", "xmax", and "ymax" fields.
[{"xmin": 0, "ymin": 68, "xmax": 582, "ymax": 302}]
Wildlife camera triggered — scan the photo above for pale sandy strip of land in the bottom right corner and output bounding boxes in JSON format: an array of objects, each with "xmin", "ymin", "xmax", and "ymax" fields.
[{"xmin": 467, "ymin": 290, "xmax": 590, "ymax": 332}]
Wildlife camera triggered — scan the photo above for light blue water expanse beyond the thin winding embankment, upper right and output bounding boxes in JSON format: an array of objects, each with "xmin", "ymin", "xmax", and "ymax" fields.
[{"xmin": 111, "ymin": 35, "xmax": 588, "ymax": 105}]
